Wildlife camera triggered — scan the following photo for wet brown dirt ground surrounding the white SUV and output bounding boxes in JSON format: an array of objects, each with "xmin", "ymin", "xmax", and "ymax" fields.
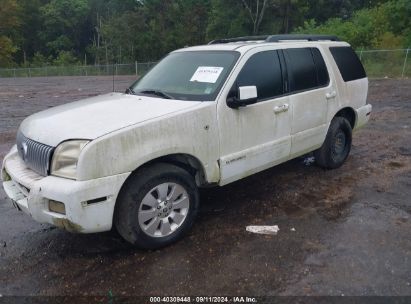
[{"xmin": 0, "ymin": 77, "xmax": 411, "ymax": 296}]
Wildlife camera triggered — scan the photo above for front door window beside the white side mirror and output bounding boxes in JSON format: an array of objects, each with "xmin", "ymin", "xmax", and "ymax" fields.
[{"xmin": 237, "ymin": 51, "xmax": 284, "ymax": 100}]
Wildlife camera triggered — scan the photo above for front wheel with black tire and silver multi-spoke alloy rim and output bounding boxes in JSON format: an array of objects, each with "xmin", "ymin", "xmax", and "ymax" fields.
[{"xmin": 114, "ymin": 163, "xmax": 199, "ymax": 249}]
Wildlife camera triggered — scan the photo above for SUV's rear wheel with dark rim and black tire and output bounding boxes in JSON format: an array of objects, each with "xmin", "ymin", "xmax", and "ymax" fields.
[{"xmin": 314, "ymin": 117, "xmax": 352, "ymax": 169}]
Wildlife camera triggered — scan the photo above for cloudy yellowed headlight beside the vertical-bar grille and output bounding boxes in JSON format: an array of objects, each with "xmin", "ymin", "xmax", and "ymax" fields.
[{"xmin": 51, "ymin": 140, "xmax": 90, "ymax": 179}]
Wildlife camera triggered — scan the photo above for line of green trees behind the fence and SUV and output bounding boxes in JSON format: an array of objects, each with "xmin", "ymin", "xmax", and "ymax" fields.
[{"xmin": 0, "ymin": 0, "xmax": 411, "ymax": 67}]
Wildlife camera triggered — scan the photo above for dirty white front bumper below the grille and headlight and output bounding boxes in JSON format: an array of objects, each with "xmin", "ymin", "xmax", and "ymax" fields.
[{"xmin": 2, "ymin": 148, "xmax": 130, "ymax": 233}]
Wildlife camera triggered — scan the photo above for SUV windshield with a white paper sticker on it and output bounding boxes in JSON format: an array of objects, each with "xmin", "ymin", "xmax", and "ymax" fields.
[{"xmin": 130, "ymin": 51, "xmax": 240, "ymax": 101}]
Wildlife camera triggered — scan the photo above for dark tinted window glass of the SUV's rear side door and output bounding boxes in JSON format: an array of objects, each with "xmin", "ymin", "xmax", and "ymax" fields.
[{"xmin": 284, "ymin": 48, "xmax": 318, "ymax": 92}]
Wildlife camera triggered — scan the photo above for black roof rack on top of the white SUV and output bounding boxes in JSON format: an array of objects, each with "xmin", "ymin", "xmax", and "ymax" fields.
[{"xmin": 208, "ymin": 35, "xmax": 340, "ymax": 44}]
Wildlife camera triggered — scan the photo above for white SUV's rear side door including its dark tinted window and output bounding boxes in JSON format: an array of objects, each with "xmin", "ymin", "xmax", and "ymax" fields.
[{"xmin": 283, "ymin": 47, "xmax": 337, "ymax": 157}]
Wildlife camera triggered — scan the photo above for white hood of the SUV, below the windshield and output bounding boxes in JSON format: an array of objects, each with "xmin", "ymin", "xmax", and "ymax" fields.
[{"xmin": 20, "ymin": 93, "xmax": 200, "ymax": 147}]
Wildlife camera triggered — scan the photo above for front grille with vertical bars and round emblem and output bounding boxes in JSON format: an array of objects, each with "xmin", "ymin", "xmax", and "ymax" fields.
[{"xmin": 17, "ymin": 132, "xmax": 54, "ymax": 176}]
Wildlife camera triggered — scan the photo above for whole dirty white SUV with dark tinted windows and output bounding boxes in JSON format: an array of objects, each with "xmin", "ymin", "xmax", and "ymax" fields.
[{"xmin": 2, "ymin": 35, "xmax": 371, "ymax": 248}]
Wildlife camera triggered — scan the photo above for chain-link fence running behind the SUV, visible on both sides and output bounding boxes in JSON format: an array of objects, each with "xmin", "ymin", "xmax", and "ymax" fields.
[{"xmin": 0, "ymin": 49, "xmax": 411, "ymax": 78}]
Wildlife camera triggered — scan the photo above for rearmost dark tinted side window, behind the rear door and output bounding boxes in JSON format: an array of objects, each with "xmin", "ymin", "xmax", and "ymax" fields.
[{"xmin": 330, "ymin": 47, "xmax": 367, "ymax": 82}]
